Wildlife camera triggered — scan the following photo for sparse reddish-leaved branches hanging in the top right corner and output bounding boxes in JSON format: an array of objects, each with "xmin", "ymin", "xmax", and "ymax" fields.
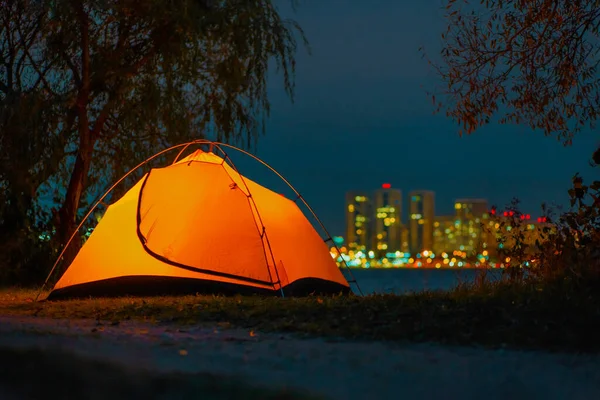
[{"xmin": 430, "ymin": 0, "xmax": 600, "ymax": 143}]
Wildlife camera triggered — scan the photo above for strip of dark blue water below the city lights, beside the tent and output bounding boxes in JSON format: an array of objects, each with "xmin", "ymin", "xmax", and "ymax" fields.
[{"xmin": 342, "ymin": 268, "xmax": 501, "ymax": 295}]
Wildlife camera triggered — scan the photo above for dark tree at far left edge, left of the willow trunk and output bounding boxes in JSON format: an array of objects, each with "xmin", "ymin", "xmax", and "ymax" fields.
[{"xmin": 0, "ymin": 1, "xmax": 70, "ymax": 280}]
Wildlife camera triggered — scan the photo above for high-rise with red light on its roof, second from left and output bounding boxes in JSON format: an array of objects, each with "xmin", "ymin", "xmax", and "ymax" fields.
[{"xmin": 373, "ymin": 183, "xmax": 402, "ymax": 257}]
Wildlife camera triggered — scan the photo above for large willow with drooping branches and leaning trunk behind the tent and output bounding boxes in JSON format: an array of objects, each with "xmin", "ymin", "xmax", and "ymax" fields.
[{"xmin": 0, "ymin": 0, "xmax": 304, "ymax": 253}]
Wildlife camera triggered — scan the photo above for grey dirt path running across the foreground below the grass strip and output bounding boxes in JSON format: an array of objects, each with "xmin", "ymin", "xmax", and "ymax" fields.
[{"xmin": 0, "ymin": 317, "xmax": 600, "ymax": 399}]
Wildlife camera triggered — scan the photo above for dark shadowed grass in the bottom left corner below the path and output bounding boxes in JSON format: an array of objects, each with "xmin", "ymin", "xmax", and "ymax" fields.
[{"xmin": 0, "ymin": 348, "xmax": 317, "ymax": 400}]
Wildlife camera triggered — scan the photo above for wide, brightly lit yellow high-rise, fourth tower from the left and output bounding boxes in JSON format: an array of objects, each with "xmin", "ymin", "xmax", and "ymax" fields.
[{"xmin": 454, "ymin": 199, "xmax": 489, "ymax": 254}]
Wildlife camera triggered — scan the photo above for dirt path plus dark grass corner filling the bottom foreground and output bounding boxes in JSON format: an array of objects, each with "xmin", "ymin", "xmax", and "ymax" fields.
[{"xmin": 0, "ymin": 315, "xmax": 600, "ymax": 399}]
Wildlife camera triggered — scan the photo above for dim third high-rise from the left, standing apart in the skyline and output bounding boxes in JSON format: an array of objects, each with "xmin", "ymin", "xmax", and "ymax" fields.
[{"xmin": 408, "ymin": 190, "xmax": 435, "ymax": 253}]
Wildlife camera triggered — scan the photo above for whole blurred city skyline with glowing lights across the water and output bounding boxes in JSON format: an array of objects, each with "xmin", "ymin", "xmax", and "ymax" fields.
[{"xmin": 342, "ymin": 188, "xmax": 547, "ymax": 269}]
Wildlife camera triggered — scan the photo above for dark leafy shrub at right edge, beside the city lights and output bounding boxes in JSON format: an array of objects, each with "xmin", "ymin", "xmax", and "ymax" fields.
[{"xmin": 486, "ymin": 166, "xmax": 600, "ymax": 287}]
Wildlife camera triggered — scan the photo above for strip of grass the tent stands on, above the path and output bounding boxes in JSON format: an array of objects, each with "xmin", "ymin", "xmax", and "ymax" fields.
[{"xmin": 0, "ymin": 278, "xmax": 600, "ymax": 352}]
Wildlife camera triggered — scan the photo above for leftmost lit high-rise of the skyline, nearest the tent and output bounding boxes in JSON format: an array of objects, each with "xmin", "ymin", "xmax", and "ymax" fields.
[{"xmin": 346, "ymin": 192, "xmax": 372, "ymax": 251}]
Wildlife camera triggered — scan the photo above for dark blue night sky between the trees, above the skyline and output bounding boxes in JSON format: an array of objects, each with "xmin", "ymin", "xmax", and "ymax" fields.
[{"xmin": 229, "ymin": 0, "xmax": 600, "ymax": 238}]
